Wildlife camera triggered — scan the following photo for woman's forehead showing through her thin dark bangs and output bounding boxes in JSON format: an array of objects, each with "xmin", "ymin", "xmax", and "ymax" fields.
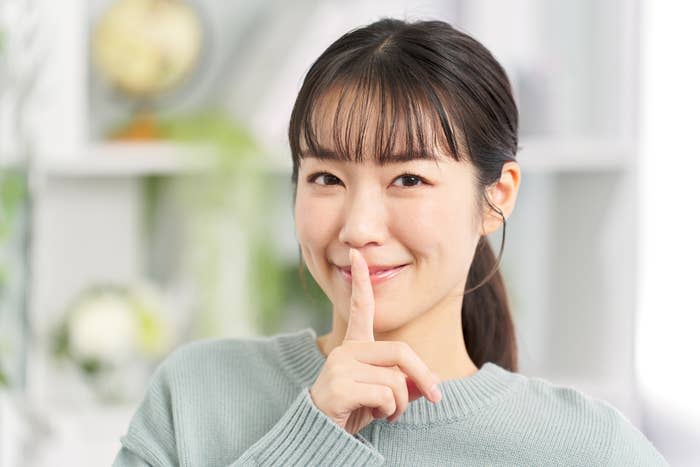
[{"xmin": 300, "ymin": 80, "xmax": 456, "ymax": 166}]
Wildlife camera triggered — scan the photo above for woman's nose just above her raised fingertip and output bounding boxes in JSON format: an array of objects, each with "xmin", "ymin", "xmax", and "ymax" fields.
[{"xmin": 338, "ymin": 190, "xmax": 387, "ymax": 249}]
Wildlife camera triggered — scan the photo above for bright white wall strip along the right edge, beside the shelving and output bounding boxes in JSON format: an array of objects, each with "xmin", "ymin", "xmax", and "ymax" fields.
[{"xmin": 636, "ymin": 1, "xmax": 700, "ymax": 466}]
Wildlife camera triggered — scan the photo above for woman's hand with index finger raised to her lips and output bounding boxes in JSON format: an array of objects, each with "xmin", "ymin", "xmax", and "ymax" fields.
[{"xmin": 309, "ymin": 248, "xmax": 441, "ymax": 435}]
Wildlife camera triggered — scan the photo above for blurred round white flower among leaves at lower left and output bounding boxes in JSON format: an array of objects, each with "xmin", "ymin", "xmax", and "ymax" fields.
[{"xmin": 68, "ymin": 294, "xmax": 139, "ymax": 365}]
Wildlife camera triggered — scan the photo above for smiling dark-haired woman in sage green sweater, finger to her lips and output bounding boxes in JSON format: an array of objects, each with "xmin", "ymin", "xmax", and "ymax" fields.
[{"xmin": 115, "ymin": 19, "xmax": 667, "ymax": 466}]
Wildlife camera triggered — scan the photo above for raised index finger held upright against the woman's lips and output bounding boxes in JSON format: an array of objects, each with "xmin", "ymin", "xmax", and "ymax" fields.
[{"xmin": 345, "ymin": 248, "xmax": 374, "ymax": 341}]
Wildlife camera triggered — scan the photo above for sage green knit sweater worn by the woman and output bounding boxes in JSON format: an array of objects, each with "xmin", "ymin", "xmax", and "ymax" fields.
[{"xmin": 114, "ymin": 328, "xmax": 668, "ymax": 467}]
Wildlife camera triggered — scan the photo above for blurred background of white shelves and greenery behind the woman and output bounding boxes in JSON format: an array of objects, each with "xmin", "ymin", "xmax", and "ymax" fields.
[{"xmin": 0, "ymin": 0, "xmax": 700, "ymax": 467}]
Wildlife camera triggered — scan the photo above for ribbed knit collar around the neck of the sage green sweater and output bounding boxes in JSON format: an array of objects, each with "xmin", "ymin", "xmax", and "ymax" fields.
[{"xmin": 273, "ymin": 328, "xmax": 527, "ymax": 426}]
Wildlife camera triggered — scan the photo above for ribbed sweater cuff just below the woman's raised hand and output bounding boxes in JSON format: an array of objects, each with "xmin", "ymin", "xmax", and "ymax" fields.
[{"xmin": 234, "ymin": 388, "xmax": 384, "ymax": 466}]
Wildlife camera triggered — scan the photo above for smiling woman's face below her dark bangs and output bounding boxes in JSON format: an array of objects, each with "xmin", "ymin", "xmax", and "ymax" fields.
[{"xmin": 294, "ymin": 102, "xmax": 480, "ymax": 332}]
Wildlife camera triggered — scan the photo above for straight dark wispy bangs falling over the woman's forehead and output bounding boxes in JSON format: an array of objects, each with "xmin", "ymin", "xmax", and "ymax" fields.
[{"xmin": 289, "ymin": 55, "xmax": 468, "ymax": 176}]
